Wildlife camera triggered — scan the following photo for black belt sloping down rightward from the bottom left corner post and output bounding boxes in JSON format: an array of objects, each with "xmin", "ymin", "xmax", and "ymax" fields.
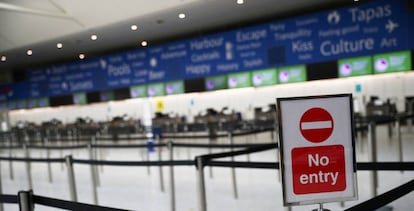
[{"xmin": 33, "ymin": 195, "xmax": 130, "ymax": 211}]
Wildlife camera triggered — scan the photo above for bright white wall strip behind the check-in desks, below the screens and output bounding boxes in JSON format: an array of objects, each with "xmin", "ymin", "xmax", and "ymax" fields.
[{"xmin": 10, "ymin": 72, "xmax": 414, "ymax": 125}]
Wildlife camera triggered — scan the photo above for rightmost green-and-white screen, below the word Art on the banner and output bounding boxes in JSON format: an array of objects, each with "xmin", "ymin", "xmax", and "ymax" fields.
[{"xmin": 374, "ymin": 51, "xmax": 411, "ymax": 74}]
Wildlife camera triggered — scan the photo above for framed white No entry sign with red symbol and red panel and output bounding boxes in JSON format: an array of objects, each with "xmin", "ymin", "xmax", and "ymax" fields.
[{"xmin": 277, "ymin": 94, "xmax": 357, "ymax": 206}]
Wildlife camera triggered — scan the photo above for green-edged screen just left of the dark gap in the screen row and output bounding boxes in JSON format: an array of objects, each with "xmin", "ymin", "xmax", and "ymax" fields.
[{"xmin": 277, "ymin": 65, "xmax": 306, "ymax": 84}]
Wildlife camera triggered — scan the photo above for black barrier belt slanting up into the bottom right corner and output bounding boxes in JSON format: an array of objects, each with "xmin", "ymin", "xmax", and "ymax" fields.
[{"xmin": 345, "ymin": 180, "xmax": 414, "ymax": 211}]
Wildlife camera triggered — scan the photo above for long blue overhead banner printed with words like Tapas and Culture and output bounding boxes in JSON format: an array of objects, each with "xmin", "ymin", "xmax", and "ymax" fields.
[{"xmin": 4, "ymin": 0, "xmax": 414, "ymax": 103}]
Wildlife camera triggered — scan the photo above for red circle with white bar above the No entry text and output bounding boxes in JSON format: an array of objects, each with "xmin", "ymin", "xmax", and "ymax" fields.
[{"xmin": 299, "ymin": 108, "xmax": 334, "ymax": 143}]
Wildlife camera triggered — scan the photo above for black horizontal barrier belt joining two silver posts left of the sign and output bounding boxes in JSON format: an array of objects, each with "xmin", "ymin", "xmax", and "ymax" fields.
[{"xmin": 73, "ymin": 159, "xmax": 194, "ymax": 166}]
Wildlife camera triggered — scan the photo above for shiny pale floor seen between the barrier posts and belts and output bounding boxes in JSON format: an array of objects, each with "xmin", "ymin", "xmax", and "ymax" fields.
[{"xmin": 0, "ymin": 126, "xmax": 414, "ymax": 211}]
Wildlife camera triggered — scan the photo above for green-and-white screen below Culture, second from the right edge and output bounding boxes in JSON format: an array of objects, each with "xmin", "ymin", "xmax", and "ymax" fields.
[{"xmin": 338, "ymin": 56, "xmax": 372, "ymax": 78}]
